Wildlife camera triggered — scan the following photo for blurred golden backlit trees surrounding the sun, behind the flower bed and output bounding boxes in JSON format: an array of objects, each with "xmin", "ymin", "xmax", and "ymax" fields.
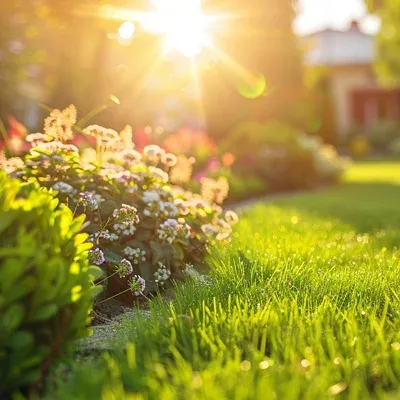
[{"xmin": 0, "ymin": 0, "xmax": 320, "ymax": 140}]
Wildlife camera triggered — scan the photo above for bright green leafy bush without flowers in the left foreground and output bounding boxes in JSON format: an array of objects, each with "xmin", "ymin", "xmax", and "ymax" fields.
[{"xmin": 0, "ymin": 171, "xmax": 101, "ymax": 398}]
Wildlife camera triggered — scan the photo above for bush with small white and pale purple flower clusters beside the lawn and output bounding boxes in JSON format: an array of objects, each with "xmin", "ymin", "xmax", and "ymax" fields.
[{"xmin": 3, "ymin": 106, "xmax": 237, "ymax": 303}]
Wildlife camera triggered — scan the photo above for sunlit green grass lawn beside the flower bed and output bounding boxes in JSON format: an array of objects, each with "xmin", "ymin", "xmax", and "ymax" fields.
[{"xmin": 48, "ymin": 162, "xmax": 400, "ymax": 400}]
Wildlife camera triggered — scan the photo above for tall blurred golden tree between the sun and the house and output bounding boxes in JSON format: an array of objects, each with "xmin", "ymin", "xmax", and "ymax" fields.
[{"xmin": 203, "ymin": 0, "xmax": 310, "ymax": 141}]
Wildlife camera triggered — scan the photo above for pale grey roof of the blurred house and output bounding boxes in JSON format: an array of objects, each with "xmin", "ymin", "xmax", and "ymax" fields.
[{"xmin": 304, "ymin": 22, "xmax": 375, "ymax": 66}]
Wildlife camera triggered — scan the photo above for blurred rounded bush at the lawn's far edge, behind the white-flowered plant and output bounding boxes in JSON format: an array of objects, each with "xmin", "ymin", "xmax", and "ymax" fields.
[{"xmin": 222, "ymin": 121, "xmax": 346, "ymax": 189}]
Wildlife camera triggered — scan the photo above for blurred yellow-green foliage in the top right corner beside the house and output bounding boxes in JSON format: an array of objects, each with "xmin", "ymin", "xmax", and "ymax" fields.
[{"xmin": 365, "ymin": 0, "xmax": 400, "ymax": 86}]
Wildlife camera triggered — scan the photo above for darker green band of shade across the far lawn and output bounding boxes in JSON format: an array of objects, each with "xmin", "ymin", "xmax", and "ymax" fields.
[{"xmin": 274, "ymin": 182, "xmax": 400, "ymax": 247}]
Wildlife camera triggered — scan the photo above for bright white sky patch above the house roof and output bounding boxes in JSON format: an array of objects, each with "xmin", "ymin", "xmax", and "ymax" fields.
[{"xmin": 295, "ymin": 0, "xmax": 379, "ymax": 33}]
